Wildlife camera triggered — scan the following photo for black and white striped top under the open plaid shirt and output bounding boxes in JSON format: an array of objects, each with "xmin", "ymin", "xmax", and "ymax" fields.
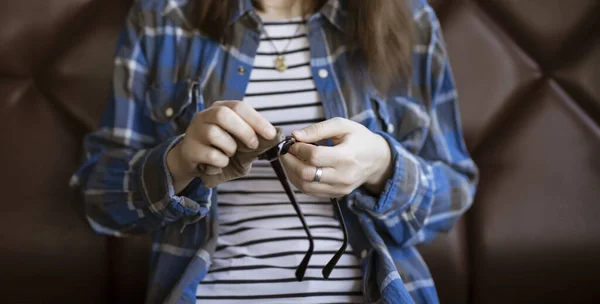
[{"xmin": 197, "ymin": 19, "xmax": 363, "ymax": 303}]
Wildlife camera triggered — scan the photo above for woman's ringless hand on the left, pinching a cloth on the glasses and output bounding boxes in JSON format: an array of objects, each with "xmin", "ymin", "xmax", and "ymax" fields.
[{"xmin": 167, "ymin": 100, "xmax": 276, "ymax": 193}]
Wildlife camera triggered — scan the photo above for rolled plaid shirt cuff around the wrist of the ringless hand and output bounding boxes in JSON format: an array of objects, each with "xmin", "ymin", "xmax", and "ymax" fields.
[{"xmin": 139, "ymin": 135, "xmax": 211, "ymax": 223}]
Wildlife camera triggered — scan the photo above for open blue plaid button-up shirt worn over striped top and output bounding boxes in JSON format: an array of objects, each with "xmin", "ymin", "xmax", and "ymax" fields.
[{"xmin": 72, "ymin": 0, "xmax": 477, "ymax": 303}]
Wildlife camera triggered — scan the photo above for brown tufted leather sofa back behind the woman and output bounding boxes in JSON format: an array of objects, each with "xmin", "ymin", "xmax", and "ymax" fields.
[{"xmin": 0, "ymin": 0, "xmax": 600, "ymax": 303}]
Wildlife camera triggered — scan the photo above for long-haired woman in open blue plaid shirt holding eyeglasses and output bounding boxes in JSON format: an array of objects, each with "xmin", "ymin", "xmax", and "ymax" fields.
[{"xmin": 75, "ymin": 0, "xmax": 477, "ymax": 303}]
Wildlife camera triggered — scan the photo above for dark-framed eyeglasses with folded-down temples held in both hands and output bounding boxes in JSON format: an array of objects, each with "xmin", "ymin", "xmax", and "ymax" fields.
[{"xmin": 258, "ymin": 136, "xmax": 348, "ymax": 281}]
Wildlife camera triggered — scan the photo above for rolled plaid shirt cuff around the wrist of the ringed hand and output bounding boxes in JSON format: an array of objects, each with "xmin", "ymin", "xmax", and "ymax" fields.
[{"xmin": 350, "ymin": 132, "xmax": 421, "ymax": 214}]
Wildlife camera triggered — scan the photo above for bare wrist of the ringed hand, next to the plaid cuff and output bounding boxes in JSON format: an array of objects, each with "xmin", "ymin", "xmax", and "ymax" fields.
[{"xmin": 363, "ymin": 134, "xmax": 393, "ymax": 194}]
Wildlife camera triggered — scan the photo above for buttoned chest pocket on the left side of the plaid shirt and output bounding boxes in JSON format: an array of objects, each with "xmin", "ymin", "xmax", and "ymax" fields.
[{"xmin": 146, "ymin": 79, "xmax": 202, "ymax": 141}]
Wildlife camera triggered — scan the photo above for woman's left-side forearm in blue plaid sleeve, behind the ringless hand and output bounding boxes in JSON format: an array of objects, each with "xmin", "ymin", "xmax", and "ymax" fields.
[{"xmin": 79, "ymin": 135, "xmax": 210, "ymax": 236}]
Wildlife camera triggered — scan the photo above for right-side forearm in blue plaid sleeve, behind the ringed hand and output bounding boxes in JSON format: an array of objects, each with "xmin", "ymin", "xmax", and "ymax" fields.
[{"xmin": 350, "ymin": 137, "xmax": 477, "ymax": 245}]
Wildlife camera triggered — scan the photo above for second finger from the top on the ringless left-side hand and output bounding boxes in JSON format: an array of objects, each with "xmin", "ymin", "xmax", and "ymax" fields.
[{"xmin": 206, "ymin": 107, "xmax": 258, "ymax": 149}]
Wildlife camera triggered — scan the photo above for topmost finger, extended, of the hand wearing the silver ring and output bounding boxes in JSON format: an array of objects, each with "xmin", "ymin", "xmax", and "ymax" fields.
[{"xmin": 292, "ymin": 117, "xmax": 356, "ymax": 143}]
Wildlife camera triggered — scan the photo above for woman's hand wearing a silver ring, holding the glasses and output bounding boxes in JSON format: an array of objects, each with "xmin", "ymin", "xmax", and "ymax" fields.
[{"xmin": 282, "ymin": 117, "xmax": 392, "ymax": 197}]
